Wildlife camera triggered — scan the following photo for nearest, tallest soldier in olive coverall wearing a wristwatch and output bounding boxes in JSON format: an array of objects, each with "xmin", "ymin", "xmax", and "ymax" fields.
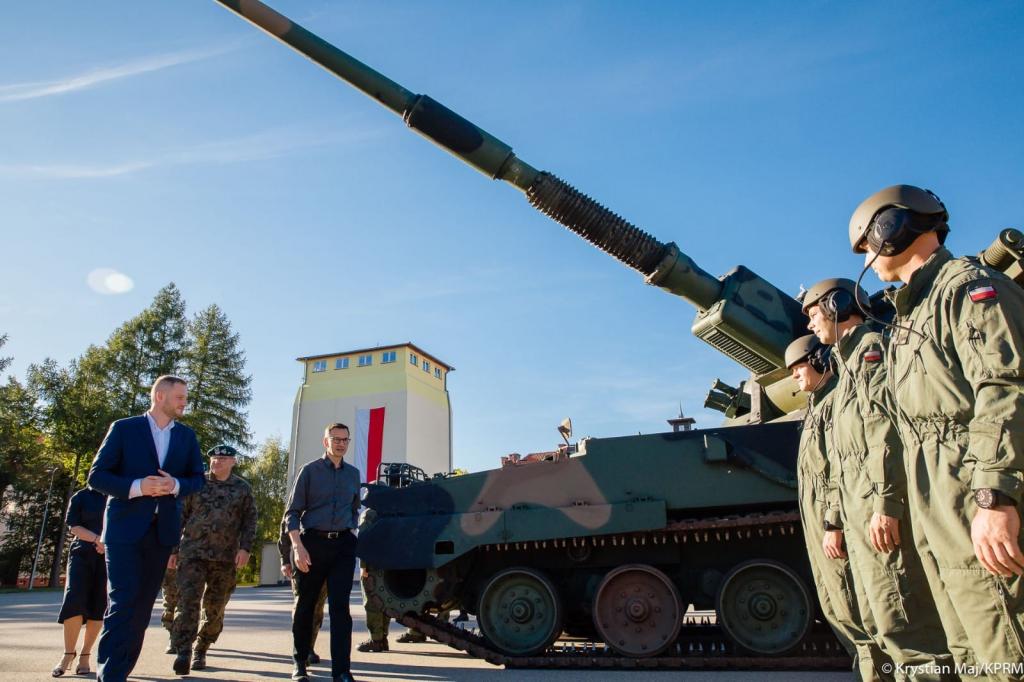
[{"xmin": 850, "ymin": 184, "xmax": 1024, "ymax": 679}]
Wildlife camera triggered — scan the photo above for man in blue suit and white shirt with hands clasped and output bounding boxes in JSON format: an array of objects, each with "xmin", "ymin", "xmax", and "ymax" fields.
[{"xmin": 89, "ymin": 376, "xmax": 204, "ymax": 682}]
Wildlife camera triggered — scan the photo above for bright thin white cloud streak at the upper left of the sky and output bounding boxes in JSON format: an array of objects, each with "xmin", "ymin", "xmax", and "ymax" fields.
[{"xmin": 0, "ymin": 45, "xmax": 237, "ymax": 102}]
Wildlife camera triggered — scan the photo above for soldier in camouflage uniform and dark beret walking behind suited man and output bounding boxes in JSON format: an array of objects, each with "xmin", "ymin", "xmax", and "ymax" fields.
[{"xmin": 171, "ymin": 445, "xmax": 256, "ymax": 675}]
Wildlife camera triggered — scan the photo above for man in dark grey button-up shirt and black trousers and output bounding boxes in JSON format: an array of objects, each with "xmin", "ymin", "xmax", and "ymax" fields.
[{"xmin": 285, "ymin": 423, "xmax": 359, "ymax": 682}]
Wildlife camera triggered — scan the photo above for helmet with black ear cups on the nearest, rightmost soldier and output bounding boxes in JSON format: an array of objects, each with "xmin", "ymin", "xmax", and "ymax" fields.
[{"xmin": 850, "ymin": 184, "xmax": 949, "ymax": 256}]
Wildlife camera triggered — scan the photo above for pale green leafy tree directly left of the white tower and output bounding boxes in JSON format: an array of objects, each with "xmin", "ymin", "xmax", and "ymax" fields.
[{"xmin": 238, "ymin": 436, "xmax": 288, "ymax": 582}]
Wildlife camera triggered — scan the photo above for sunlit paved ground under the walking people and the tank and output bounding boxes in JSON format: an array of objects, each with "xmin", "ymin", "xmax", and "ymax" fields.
[{"xmin": 0, "ymin": 588, "xmax": 853, "ymax": 682}]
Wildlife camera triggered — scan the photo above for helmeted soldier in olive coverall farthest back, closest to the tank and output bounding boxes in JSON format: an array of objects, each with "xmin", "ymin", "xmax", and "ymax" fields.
[{"xmin": 785, "ymin": 334, "xmax": 892, "ymax": 680}]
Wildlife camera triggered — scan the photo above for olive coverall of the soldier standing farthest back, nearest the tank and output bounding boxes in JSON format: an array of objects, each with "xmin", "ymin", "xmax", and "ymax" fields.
[{"xmin": 797, "ymin": 377, "xmax": 889, "ymax": 680}]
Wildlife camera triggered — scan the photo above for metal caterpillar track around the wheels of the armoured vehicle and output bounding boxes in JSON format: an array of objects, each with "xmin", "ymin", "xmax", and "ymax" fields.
[{"xmin": 380, "ymin": 511, "xmax": 851, "ymax": 670}]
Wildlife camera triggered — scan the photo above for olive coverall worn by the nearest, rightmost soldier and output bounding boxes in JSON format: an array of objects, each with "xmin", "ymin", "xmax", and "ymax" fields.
[{"xmin": 887, "ymin": 248, "xmax": 1024, "ymax": 679}]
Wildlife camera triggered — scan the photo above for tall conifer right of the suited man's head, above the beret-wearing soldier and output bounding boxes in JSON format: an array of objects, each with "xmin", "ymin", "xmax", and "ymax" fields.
[{"xmin": 181, "ymin": 304, "xmax": 252, "ymax": 451}]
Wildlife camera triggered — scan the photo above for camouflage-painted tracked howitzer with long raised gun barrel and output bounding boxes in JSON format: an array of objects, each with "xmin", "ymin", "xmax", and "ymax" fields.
[{"xmin": 211, "ymin": 0, "xmax": 1024, "ymax": 668}]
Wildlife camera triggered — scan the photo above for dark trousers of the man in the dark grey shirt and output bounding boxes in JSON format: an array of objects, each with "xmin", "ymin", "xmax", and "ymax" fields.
[{"xmin": 292, "ymin": 531, "xmax": 355, "ymax": 677}]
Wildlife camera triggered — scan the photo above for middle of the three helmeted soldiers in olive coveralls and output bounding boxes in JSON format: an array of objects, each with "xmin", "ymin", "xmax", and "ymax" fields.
[{"xmin": 804, "ymin": 279, "xmax": 955, "ymax": 679}]
